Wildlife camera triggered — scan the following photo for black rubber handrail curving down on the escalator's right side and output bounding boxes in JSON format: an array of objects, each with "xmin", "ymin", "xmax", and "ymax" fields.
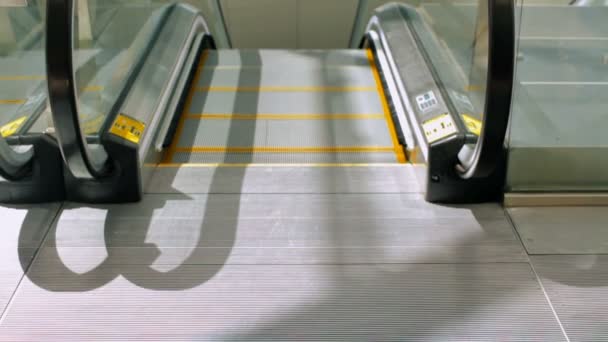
[{"xmin": 456, "ymin": 0, "xmax": 515, "ymax": 179}]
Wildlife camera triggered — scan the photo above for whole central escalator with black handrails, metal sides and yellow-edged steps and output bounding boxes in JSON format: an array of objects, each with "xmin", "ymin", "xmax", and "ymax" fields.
[{"xmin": 39, "ymin": 0, "xmax": 515, "ymax": 203}]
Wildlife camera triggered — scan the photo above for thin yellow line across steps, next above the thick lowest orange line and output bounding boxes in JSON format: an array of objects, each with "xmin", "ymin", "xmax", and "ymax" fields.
[{"xmin": 187, "ymin": 114, "xmax": 384, "ymax": 120}]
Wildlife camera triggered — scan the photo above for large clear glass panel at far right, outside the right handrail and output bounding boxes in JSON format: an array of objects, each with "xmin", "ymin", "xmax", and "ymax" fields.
[{"xmin": 508, "ymin": 0, "xmax": 608, "ymax": 192}]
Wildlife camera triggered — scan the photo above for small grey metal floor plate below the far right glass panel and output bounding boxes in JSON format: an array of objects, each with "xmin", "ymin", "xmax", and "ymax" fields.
[{"xmin": 508, "ymin": 207, "xmax": 608, "ymax": 254}]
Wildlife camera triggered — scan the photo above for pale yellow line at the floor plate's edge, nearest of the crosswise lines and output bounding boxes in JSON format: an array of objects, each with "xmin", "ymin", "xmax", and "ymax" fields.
[{"xmin": 152, "ymin": 163, "xmax": 404, "ymax": 169}]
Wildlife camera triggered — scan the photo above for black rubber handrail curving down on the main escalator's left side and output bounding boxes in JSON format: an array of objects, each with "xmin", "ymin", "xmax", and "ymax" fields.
[{"xmin": 46, "ymin": 0, "xmax": 108, "ymax": 179}]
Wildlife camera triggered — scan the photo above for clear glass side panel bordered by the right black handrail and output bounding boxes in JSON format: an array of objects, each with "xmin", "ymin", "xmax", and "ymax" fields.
[{"xmin": 353, "ymin": 0, "xmax": 488, "ymax": 142}]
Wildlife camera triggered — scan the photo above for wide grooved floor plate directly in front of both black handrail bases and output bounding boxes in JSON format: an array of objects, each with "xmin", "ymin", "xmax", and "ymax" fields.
[{"xmin": 40, "ymin": 194, "xmax": 528, "ymax": 265}]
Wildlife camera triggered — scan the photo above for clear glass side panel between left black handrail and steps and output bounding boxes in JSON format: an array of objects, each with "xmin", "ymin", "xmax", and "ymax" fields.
[{"xmin": 73, "ymin": 0, "xmax": 227, "ymax": 138}]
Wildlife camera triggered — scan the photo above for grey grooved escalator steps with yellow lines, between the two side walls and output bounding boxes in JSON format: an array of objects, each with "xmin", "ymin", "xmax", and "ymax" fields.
[{"xmin": 165, "ymin": 50, "xmax": 403, "ymax": 164}]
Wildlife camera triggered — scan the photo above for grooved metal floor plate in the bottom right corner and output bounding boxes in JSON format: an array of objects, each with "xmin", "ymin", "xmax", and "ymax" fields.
[{"xmin": 531, "ymin": 255, "xmax": 608, "ymax": 342}]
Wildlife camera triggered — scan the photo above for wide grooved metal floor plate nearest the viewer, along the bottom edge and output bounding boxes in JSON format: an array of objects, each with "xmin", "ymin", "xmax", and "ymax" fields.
[{"xmin": 0, "ymin": 260, "xmax": 564, "ymax": 341}]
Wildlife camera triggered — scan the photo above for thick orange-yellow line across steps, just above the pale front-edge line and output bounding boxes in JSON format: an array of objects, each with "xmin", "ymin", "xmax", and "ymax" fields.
[{"xmin": 173, "ymin": 146, "xmax": 395, "ymax": 154}]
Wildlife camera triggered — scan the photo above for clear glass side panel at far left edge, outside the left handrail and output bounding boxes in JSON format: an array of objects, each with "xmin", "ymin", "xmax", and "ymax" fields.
[{"xmin": 0, "ymin": 1, "xmax": 50, "ymax": 140}]
